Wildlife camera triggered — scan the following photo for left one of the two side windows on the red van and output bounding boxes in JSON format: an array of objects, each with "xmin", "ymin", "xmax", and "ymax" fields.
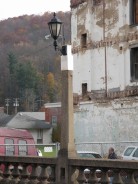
[{"xmin": 5, "ymin": 139, "xmax": 15, "ymax": 156}]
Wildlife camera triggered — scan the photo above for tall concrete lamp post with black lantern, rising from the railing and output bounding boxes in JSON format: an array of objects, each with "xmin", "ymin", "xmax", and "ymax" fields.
[{"xmin": 48, "ymin": 13, "xmax": 76, "ymax": 184}]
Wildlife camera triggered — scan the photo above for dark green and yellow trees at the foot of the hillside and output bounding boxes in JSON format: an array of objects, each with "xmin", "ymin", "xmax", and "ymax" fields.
[{"xmin": 8, "ymin": 53, "xmax": 59, "ymax": 111}]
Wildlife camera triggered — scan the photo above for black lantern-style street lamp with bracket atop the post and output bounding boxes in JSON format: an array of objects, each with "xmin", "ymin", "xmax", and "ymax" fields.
[{"xmin": 48, "ymin": 12, "xmax": 67, "ymax": 55}]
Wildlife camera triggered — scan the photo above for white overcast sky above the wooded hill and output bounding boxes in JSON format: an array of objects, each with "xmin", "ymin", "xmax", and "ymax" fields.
[{"xmin": 0, "ymin": 0, "xmax": 70, "ymax": 20}]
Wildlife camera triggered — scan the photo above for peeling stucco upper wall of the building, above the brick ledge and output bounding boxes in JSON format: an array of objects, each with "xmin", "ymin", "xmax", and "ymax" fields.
[{"xmin": 71, "ymin": 0, "xmax": 138, "ymax": 94}]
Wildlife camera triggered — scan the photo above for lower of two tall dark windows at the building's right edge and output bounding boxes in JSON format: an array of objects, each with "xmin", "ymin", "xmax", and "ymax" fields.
[{"xmin": 130, "ymin": 47, "xmax": 138, "ymax": 81}]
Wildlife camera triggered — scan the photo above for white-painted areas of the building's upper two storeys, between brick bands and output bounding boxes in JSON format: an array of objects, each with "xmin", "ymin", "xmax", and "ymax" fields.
[{"xmin": 71, "ymin": 0, "xmax": 137, "ymax": 95}]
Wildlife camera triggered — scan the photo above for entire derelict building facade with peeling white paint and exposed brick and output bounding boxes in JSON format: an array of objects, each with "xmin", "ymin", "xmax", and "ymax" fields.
[{"xmin": 71, "ymin": 0, "xmax": 138, "ymax": 153}]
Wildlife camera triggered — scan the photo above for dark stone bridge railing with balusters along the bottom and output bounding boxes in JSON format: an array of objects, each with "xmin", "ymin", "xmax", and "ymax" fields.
[{"xmin": 0, "ymin": 156, "xmax": 138, "ymax": 184}]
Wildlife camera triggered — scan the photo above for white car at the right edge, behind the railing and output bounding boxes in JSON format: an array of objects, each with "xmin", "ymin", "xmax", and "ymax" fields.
[{"xmin": 122, "ymin": 146, "xmax": 138, "ymax": 160}]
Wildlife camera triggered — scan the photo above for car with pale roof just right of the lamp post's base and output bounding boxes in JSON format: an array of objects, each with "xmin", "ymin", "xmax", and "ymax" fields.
[{"xmin": 77, "ymin": 151, "xmax": 102, "ymax": 158}]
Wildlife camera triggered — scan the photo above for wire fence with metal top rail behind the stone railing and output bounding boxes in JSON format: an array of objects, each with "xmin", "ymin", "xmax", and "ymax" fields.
[{"xmin": 0, "ymin": 141, "xmax": 138, "ymax": 157}]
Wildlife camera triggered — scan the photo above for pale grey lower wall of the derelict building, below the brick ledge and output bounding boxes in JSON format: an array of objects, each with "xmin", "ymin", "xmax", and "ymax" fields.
[{"xmin": 74, "ymin": 98, "xmax": 138, "ymax": 153}]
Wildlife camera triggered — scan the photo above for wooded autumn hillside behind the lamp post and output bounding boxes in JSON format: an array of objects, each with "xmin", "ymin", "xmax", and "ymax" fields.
[{"xmin": 0, "ymin": 12, "xmax": 70, "ymax": 114}]
